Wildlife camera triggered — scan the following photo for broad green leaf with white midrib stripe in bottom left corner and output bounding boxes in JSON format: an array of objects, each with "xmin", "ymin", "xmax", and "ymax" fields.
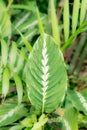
[{"xmin": 0, "ymin": 101, "xmax": 27, "ymax": 127}]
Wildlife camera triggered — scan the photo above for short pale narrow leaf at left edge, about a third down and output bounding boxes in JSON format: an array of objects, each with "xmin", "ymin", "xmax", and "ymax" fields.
[{"xmin": 1, "ymin": 40, "xmax": 8, "ymax": 66}]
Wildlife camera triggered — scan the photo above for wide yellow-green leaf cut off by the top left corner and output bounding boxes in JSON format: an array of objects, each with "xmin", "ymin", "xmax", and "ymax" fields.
[{"xmin": 0, "ymin": 0, "xmax": 11, "ymax": 38}]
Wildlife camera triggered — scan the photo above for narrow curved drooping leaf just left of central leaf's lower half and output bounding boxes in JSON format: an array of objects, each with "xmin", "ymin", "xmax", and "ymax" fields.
[{"xmin": 14, "ymin": 73, "xmax": 23, "ymax": 104}]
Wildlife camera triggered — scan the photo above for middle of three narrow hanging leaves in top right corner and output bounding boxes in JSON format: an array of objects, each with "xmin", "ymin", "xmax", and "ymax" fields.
[{"xmin": 72, "ymin": 0, "xmax": 80, "ymax": 33}]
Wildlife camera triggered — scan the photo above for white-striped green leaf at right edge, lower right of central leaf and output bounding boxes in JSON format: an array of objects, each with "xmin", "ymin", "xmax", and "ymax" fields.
[{"xmin": 68, "ymin": 90, "xmax": 87, "ymax": 115}]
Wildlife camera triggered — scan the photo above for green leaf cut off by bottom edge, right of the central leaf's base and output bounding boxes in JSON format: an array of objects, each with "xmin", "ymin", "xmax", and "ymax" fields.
[{"xmin": 63, "ymin": 108, "xmax": 78, "ymax": 130}]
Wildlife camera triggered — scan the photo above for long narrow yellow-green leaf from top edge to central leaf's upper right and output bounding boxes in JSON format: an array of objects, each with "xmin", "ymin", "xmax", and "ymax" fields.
[{"xmin": 49, "ymin": 0, "xmax": 60, "ymax": 46}]
